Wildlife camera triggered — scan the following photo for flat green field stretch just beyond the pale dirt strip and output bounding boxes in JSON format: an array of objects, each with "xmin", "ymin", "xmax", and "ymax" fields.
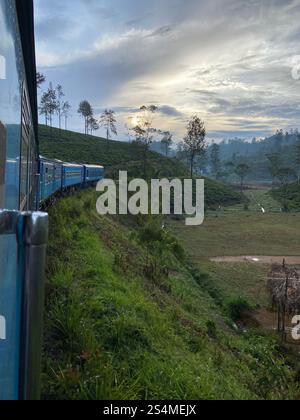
[{"xmin": 172, "ymin": 209, "xmax": 300, "ymax": 260}]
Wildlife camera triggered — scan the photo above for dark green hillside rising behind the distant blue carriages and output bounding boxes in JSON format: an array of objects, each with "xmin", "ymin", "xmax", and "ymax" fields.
[{"xmin": 39, "ymin": 126, "xmax": 187, "ymax": 177}]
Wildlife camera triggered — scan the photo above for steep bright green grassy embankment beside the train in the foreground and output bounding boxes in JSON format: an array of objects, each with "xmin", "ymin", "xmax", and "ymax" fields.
[{"xmin": 43, "ymin": 191, "xmax": 299, "ymax": 399}]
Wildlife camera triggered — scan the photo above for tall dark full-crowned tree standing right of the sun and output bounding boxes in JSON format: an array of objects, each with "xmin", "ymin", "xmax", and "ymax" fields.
[{"xmin": 184, "ymin": 115, "xmax": 207, "ymax": 177}]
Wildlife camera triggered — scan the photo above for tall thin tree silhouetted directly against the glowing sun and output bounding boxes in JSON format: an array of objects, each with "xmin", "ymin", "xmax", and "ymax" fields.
[{"xmin": 131, "ymin": 105, "xmax": 158, "ymax": 179}]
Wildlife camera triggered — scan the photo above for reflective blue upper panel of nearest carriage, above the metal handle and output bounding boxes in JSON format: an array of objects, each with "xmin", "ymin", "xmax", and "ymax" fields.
[{"xmin": 0, "ymin": 0, "xmax": 25, "ymax": 210}]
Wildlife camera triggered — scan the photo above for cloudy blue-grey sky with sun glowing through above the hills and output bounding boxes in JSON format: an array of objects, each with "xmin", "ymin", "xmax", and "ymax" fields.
[{"xmin": 34, "ymin": 0, "xmax": 300, "ymax": 140}]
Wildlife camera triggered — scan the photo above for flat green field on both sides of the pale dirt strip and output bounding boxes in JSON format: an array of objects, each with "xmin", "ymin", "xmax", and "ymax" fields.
[{"xmin": 170, "ymin": 189, "xmax": 300, "ymax": 318}]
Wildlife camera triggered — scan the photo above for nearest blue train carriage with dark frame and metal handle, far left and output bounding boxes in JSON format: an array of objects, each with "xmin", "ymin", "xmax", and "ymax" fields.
[{"xmin": 0, "ymin": 0, "xmax": 48, "ymax": 400}]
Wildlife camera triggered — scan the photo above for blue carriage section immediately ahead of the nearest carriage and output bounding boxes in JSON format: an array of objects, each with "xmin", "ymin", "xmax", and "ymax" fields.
[{"xmin": 38, "ymin": 156, "xmax": 63, "ymax": 205}]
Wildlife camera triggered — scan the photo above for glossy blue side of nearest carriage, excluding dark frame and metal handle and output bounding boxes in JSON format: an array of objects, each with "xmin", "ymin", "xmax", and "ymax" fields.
[{"xmin": 0, "ymin": 0, "xmax": 32, "ymax": 400}]
